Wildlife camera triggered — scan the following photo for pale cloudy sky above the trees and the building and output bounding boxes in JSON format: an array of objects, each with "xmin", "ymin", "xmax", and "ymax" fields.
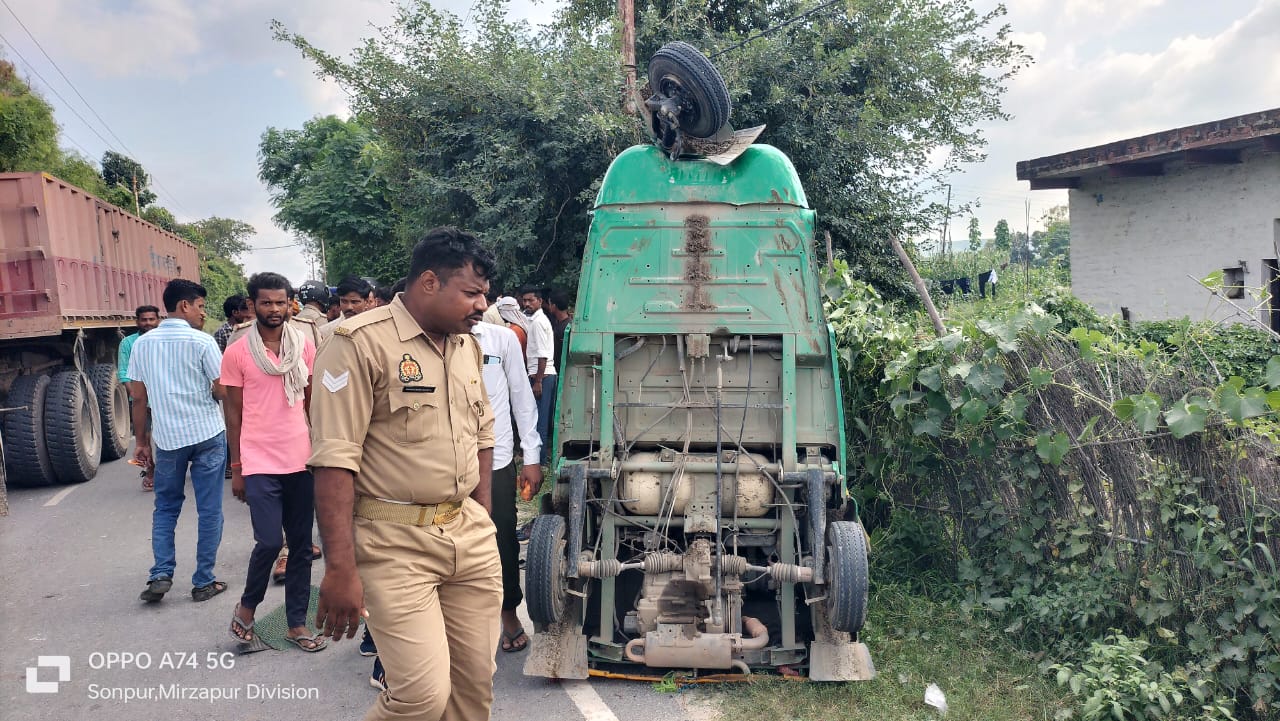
[{"xmin": 0, "ymin": 0, "xmax": 1280, "ymax": 283}]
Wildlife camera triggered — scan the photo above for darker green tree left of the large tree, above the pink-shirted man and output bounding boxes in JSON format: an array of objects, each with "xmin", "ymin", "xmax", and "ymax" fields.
[{"xmin": 259, "ymin": 115, "xmax": 396, "ymax": 279}]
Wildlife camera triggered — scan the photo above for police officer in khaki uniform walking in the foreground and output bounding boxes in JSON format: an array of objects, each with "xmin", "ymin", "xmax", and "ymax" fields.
[{"xmin": 310, "ymin": 228, "xmax": 502, "ymax": 721}]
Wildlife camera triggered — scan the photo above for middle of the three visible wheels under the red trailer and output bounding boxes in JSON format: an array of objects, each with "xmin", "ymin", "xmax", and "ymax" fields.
[{"xmin": 45, "ymin": 369, "xmax": 102, "ymax": 483}]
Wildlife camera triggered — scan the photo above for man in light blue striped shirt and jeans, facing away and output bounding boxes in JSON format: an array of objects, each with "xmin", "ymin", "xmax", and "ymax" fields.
[{"xmin": 128, "ymin": 278, "xmax": 227, "ymax": 603}]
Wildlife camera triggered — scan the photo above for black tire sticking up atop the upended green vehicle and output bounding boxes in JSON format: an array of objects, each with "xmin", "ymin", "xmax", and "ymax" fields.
[{"xmin": 649, "ymin": 41, "xmax": 732, "ymax": 138}]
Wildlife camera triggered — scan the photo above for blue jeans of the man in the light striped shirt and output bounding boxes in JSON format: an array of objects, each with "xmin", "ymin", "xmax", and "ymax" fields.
[{"xmin": 150, "ymin": 433, "xmax": 227, "ymax": 588}]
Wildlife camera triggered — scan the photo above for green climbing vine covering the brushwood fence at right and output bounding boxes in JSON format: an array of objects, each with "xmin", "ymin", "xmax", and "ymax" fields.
[{"xmin": 826, "ymin": 265, "xmax": 1280, "ymax": 718}]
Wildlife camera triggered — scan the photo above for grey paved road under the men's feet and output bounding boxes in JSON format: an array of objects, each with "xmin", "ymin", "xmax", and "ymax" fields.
[{"xmin": 0, "ymin": 453, "xmax": 714, "ymax": 721}]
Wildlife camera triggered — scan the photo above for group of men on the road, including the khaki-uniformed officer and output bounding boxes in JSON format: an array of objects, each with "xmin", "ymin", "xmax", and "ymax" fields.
[{"xmin": 119, "ymin": 228, "xmax": 571, "ymax": 720}]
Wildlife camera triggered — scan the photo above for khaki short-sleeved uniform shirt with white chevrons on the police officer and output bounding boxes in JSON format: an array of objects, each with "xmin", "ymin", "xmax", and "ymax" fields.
[{"xmin": 307, "ymin": 297, "xmax": 494, "ymax": 503}]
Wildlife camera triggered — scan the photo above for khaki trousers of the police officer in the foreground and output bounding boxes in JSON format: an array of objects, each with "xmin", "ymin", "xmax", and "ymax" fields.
[{"xmin": 355, "ymin": 498, "xmax": 502, "ymax": 721}]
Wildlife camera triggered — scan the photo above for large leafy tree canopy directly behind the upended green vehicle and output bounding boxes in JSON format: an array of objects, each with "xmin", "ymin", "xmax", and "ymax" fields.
[{"xmin": 272, "ymin": 0, "xmax": 1027, "ymax": 296}]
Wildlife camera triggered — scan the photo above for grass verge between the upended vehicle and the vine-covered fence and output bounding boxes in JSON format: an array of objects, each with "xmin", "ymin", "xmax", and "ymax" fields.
[{"xmin": 713, "ymin": 585, "xmax": 1075, "ymax": 721}]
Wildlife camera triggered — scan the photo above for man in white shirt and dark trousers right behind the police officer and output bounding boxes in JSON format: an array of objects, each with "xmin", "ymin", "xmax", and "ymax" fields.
[{"xmin": 471, "ymin": 323, "xmax": 543, "ymax": 652}]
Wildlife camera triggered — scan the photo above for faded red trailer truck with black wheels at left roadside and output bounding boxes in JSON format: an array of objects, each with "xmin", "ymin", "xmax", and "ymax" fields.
[{"xmin": 0, "ymin": 173, "xmax": 200, "ymax": 505}]
